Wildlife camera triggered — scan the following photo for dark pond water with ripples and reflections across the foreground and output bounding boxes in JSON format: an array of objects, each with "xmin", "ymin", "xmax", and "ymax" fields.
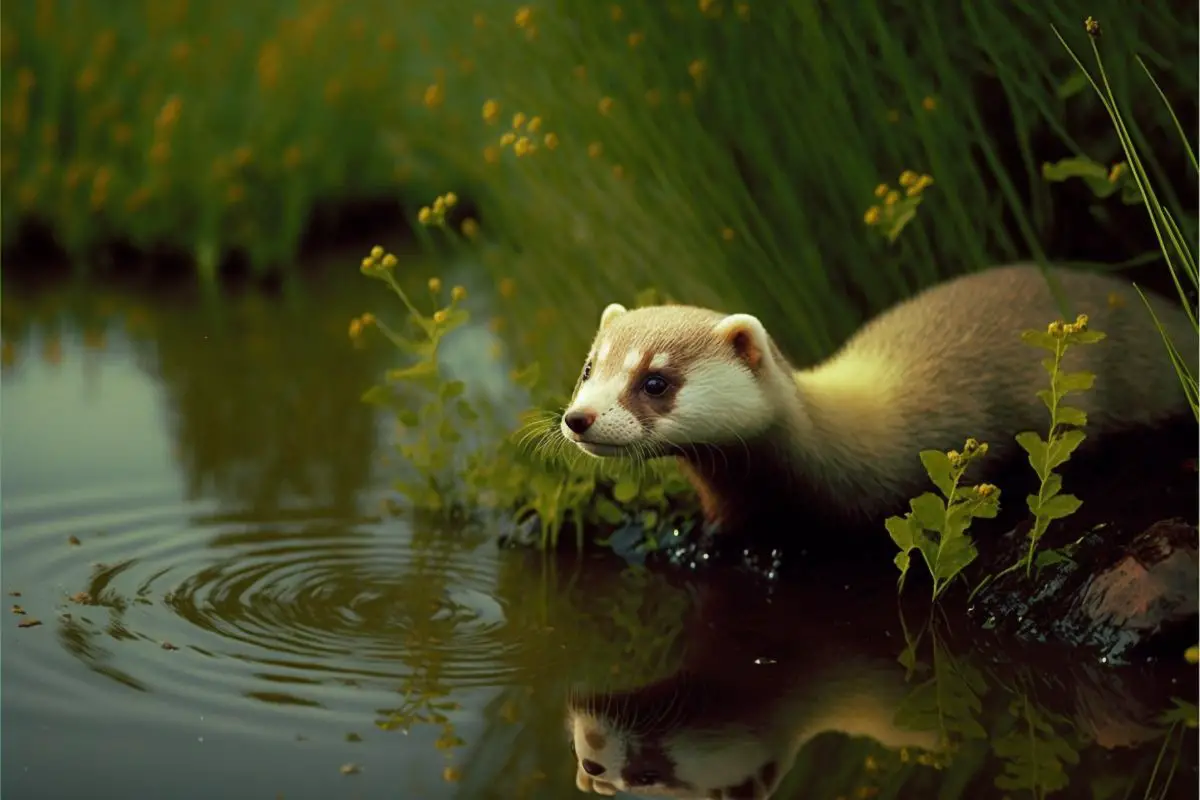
[{"xmin": 0, "ymin": 258, "xmax": 1196, "ymax": 799}]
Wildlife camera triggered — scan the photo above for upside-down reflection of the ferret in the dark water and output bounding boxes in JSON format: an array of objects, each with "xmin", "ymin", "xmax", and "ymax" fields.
[{"xmin": 566, "ymin": 655, "xmax": 936, "ymax": 800}]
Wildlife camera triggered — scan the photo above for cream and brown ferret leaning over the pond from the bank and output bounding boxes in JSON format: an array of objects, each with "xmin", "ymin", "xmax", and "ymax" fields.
[{"xmin": 559, "ymin": 264, "xmax": 1198, "ymax": 529}]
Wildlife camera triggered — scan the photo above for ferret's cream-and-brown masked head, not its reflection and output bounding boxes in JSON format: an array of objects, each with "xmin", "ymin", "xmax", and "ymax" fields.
[{"xmin": 560, "ymin": 303, "xmax": 794, "ymax": 457}]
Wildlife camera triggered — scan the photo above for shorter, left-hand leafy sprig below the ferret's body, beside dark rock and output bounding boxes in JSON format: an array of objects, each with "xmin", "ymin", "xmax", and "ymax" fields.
[{"xmin": 884, "ymin": 439, "xmax": 1000, "ymax": 600}]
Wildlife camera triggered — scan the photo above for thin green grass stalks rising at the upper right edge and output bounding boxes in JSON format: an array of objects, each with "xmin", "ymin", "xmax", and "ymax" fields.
[{"xmin": 1046, "ymin": 17, "xmax": 1200, "ymax": 420}]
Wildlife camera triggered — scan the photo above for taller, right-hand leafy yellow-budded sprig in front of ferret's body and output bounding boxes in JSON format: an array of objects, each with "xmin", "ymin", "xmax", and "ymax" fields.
[{"xmin": 1015, "ymin": 314, "xmax": 1104, "ymax": 576}]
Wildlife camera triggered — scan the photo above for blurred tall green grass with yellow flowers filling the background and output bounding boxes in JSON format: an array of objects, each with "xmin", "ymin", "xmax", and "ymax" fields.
[{"xmin": 0, "ymin": 0, "xmax": 1198, "ymax": 367}]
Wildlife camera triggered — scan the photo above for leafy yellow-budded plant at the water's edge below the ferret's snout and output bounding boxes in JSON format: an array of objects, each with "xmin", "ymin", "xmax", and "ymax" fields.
[{"xmin": 350, "ymin": 232, "xmax": 695, "ymax": 547}]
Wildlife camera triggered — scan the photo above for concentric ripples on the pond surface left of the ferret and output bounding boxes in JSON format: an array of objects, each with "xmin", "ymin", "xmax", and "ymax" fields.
[{"xmin": 2, "ymin": 479, "xmax": 516, "ymax": 732}]
